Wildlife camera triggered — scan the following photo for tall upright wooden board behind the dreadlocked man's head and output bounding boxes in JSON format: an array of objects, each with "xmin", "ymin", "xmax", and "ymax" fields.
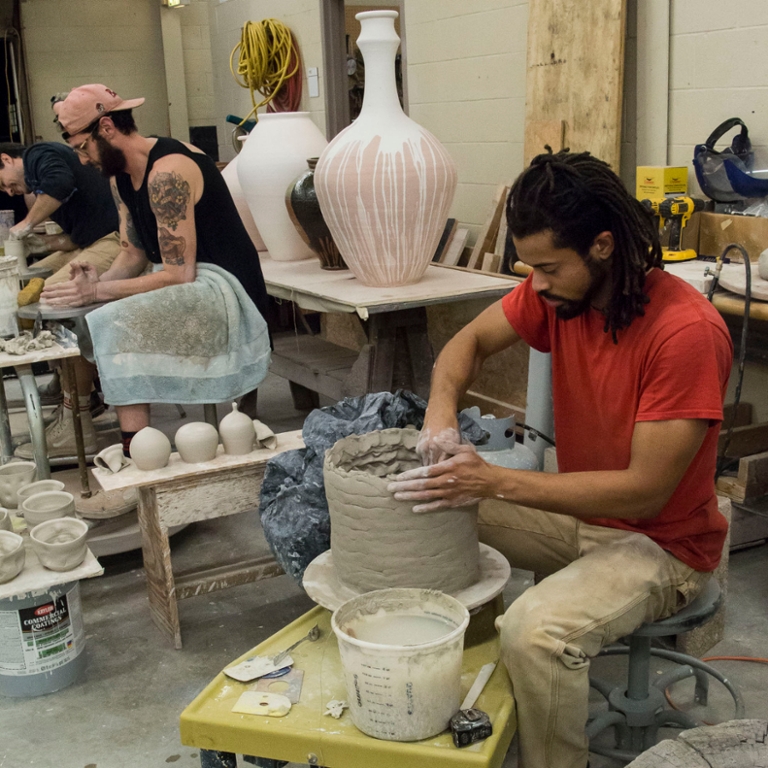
[{"xmin": 524, "ymin": 0, "xmax": 626, "ymax": 172}]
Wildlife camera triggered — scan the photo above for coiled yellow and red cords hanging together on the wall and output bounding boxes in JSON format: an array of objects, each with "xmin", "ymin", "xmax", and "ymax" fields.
[{"xmin": 229, "ymin": 19, "xmax": 302, "ymax": 125}]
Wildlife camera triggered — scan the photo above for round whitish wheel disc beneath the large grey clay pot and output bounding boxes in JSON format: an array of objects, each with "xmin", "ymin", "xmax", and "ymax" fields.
[{"xmin": 303, "ymin": 544, "xmax": 512, "ymax": 611}]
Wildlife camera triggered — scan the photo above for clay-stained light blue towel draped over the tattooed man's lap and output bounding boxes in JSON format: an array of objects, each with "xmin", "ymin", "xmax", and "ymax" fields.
[{"xmin": 86, "ymin": 264, "xmax": 270, "ymax": 405}]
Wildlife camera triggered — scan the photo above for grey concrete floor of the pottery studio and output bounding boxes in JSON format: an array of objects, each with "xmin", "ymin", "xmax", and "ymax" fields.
[{"xmin": 0, "ymin": 370, "xmax": 768, "ymax": 768}]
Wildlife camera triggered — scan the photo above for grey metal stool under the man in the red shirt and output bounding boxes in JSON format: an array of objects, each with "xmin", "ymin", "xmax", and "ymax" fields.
[{"xmin": 587, "ymin": 578, "xmax": 744, "ymax": 761}]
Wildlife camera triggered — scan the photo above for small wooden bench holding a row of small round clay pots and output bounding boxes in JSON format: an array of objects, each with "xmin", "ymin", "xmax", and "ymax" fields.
[{"xmin": 93, "ymin": 430, "xmax": 304, "ymax": 649}]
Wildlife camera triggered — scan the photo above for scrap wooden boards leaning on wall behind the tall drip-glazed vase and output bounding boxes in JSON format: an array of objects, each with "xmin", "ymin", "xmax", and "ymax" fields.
[{"xmin": 432, "ymin": 184, "xmax": 510, "ymax": 274}]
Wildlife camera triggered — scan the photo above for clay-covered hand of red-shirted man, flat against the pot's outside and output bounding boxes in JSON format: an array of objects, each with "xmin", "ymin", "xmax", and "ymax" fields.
[{"xmin": 387, "ymin": 445, "xmax": 494, "ymax": 512}]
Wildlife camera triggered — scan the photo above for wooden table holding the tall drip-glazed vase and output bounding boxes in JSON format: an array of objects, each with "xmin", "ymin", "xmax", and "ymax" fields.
[{"xmin": 261, "ymin": 258, "xmax": 520, "ymax": 400}]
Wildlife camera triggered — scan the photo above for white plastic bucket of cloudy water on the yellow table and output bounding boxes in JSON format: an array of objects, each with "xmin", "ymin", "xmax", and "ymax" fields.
[{"xmin": 331, "ymin": 589, "xmax": 469, "ymax": 741}]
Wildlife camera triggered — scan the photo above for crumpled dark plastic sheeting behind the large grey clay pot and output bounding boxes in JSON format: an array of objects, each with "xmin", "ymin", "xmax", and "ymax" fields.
[{"xmin": 259, "ymin": 390, "xmax": 485, "ymax": 583}]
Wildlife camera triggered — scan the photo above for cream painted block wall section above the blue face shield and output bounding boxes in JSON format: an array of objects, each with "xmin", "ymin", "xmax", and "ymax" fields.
[{"xmin": 669, "ymin": 0, "xmax": 768, "ymax": 192}]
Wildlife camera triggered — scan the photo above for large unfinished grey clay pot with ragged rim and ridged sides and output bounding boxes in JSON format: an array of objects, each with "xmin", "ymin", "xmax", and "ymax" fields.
[{"xmin": 323, "ymin": 429, "xmax": 480, "ymax": 592}]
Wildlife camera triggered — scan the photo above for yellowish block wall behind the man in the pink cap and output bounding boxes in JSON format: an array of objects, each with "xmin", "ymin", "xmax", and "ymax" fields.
[{"xmin": 21, "ymin": 0, "xmax": 168, "ymax": 141}]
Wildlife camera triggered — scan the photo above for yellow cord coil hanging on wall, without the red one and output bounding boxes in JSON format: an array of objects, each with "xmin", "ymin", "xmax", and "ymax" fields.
[{"xmin": 229, "ymin": 19, "xmax": 301, "ymax": 125}]
